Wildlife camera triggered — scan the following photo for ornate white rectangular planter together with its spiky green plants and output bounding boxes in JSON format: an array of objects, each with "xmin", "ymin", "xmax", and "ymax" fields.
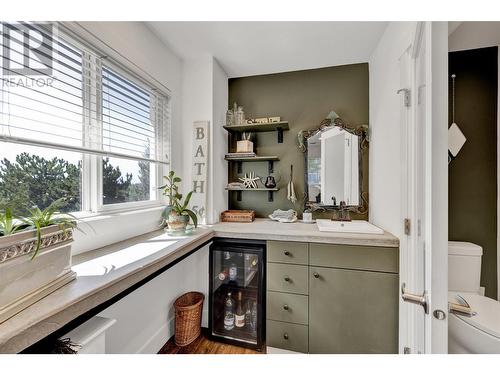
[{"xmin": 0, "ymin": 199, "xmax": 76, "ymax": 323}]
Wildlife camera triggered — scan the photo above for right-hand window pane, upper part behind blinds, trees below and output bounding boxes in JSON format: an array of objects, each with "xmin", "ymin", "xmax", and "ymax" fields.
[{"xmin": 102, "ymin": 67, "xmax": 156, "ymax": 205}]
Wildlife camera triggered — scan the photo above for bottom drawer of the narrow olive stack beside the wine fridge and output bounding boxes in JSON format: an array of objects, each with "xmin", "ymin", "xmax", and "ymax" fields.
[{"xmin": 266, "ymin": 320, "xmax": 309, "ymax": 353}]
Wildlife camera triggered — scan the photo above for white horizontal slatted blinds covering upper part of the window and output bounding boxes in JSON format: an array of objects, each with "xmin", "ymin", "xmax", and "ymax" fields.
[{"xmin": 0, "ymin": 23, "xmax": 169, "ymax": 164}]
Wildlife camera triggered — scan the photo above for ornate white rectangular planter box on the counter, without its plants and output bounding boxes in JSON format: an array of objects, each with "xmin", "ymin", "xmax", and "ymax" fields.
[{"xmin": 0, "ymin": 225, "xmax": 76, "ymax": 323}]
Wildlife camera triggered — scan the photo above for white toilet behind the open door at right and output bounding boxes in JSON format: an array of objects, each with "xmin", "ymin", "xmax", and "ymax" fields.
[{"xmin": 448, "ymin": 241, "xmax": 500, "ymax": 354}]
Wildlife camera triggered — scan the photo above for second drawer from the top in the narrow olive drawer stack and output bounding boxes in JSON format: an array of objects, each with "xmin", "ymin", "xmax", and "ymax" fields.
[{"xmin": 267, "ymin": 263, "xmax": 309, "ymax": 294}]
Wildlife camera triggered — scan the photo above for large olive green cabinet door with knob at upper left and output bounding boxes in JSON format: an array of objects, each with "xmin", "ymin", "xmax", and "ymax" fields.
[{"xmin": 309, "ymin": 267, "xmax": 398, "ymax": 354}]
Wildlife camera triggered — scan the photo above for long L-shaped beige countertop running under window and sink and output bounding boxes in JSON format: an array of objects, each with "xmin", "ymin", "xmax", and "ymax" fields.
[{"xmin": 0, "ymin": 219, "xmax": 399, "ymax": 353}]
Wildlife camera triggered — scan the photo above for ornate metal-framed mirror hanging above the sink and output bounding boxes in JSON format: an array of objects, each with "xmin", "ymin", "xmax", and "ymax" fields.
[{"xmin": 299, "ymin": 112, "xmax": 368, "ymax": 213}]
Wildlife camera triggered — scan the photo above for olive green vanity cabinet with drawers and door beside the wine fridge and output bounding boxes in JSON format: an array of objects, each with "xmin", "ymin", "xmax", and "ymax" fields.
[{"xmin": 266, "ymin": 241, "xmax": 399, "ymax": 354}]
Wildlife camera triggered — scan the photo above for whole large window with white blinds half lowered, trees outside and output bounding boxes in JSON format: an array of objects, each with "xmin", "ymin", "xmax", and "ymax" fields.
[{"xmin": 0, "ymin": 23, "xmax": 169, "ymax": 212}]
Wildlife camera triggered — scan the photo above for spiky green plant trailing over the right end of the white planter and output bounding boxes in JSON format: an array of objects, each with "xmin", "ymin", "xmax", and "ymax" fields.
[{"xmin": 21, "ymin": 198, "xmax": 77, "ymax": 259}]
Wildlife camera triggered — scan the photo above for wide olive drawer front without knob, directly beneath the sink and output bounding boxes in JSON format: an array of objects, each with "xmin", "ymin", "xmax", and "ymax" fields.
[{"xmin": 309, "ymin": 243, "xmax": 399, "ymax": 273}]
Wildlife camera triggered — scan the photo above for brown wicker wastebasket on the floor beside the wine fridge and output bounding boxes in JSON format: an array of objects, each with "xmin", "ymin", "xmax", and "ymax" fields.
[{"xmin": 174, "ymin": 292, "xmax": 205, "ymax": 346}]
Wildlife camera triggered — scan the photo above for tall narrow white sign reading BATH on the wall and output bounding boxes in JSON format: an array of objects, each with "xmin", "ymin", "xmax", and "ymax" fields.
[{"xmin": 191, "ymin": 121, "xmax": 209, "ymax": 224}]
